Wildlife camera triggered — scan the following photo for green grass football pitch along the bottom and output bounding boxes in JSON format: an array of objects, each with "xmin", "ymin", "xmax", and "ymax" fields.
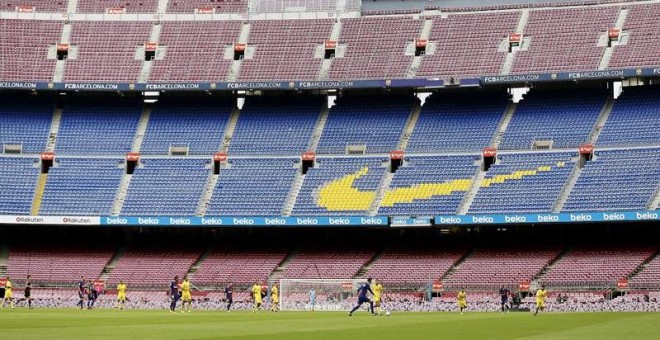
[{"xmin": 0, "ymin": 309, "xmax": 660, "ymax": 340}]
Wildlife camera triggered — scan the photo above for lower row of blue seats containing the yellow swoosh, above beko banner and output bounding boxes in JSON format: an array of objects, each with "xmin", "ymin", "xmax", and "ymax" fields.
[{"xmin": 0, "ymin": 148, "xmax": 660, "ymax": 216}]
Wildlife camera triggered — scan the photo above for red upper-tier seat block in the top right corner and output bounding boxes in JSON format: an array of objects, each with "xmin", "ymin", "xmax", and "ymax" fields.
[{"xmin": 609, "ymin": 4, "xmax": 660, "ymax": 69}]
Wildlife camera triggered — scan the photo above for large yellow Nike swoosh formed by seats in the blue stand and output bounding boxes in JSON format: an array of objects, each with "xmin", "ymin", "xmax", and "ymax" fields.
[{"xmin": 316, "ymin": 162, "xmax": 566, "ymax": 211}]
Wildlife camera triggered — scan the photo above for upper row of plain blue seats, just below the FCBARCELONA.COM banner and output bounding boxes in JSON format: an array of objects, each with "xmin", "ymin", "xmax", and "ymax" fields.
[{"xmin": 5, "ymin": 86, "xmax": 660, "ymax": 156}]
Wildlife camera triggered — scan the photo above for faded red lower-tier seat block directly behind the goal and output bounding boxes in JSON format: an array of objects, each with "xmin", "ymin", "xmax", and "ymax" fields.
[{"xmin": 281, "ymin": 247, "xmax": 374, "ymax": 279}]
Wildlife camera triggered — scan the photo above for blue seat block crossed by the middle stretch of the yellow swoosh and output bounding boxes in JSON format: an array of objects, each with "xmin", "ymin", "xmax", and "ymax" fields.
[{"xmin": 378, "ymin": 156, "xmax": 478, "ymax": 216}]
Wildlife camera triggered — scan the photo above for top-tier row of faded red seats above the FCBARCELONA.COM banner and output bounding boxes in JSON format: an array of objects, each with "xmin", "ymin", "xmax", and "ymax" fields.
[{"xmin": 0, "ymin": 1, "xmax": 660, "ymax": 83}]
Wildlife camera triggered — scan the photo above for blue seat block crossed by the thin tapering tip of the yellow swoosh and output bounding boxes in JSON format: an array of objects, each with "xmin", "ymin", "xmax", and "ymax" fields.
[{"xmin": 469, "ymin": 153, "xmax": 573, "ymax": 213}]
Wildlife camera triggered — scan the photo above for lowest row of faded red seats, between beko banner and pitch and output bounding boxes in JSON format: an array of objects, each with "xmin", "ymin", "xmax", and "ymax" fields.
[{"xmin": 7, "ymin": 246, "xmax": 660, "ymax": 290}]
